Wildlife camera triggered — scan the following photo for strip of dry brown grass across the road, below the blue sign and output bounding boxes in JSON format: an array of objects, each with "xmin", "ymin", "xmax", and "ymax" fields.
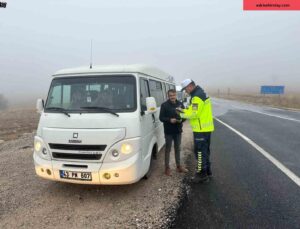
[{"xmin": 212, "ymin": 94, "xmax": 300, "ymax": 109}]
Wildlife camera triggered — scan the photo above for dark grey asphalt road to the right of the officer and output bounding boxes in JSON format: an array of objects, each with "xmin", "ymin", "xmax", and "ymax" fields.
[{"xmin": 172, "ymin": 99, "xmax": 300, "ymax": 228}]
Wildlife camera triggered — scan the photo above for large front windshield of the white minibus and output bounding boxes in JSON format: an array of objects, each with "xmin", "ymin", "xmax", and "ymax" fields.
[{"xmin": 45, "ymin": 75, "xmax": 137, "ymax": 113}]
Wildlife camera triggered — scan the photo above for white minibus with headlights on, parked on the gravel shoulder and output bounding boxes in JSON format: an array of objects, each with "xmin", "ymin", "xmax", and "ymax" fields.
[{"xmin": 33, "ymin": 65, "xmax": 175, "ymax": 185}]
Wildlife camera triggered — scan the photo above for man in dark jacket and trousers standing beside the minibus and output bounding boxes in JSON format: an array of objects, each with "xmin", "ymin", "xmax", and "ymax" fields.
[{"xmin": 159, "ymin": 89, "xmax": 187, "ymax": 176}]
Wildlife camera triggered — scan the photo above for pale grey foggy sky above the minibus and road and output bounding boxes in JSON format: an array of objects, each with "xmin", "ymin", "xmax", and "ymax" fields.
[{"xmin": 0, "ymin": 0, "xmax": 300, "ymax": 107}]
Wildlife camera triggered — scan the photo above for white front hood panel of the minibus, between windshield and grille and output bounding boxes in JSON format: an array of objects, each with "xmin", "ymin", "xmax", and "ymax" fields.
[{"xmin": 38, "ymin": 113, "xmax": 126, "ymax": 144}]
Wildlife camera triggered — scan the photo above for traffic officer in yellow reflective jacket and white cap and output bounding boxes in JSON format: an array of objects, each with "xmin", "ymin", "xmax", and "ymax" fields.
[{"xmin": 178, "ymin": 79, "xmax": 214, "ymax": 183}]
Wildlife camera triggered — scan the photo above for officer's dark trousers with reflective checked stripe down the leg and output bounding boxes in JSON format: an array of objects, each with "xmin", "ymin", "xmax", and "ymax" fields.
[{"xmin": 194, "ymin": 132, "xmax": 211, "ymax": 173}]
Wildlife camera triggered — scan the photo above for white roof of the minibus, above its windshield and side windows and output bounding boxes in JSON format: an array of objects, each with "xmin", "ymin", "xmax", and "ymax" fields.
[{"xmin": 53, "ymin": 64, "xmax": 173, "ymax": 81}]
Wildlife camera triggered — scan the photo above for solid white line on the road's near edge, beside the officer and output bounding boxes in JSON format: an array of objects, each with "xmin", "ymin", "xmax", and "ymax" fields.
[{"xmin": 215, "ymin": 118, "xmax": 300, "ymax": 187}]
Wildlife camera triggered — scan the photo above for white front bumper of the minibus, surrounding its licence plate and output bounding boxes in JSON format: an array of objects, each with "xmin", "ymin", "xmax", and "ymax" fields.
[{"xmin": 33, "ymin": 153, "xmax": 142, "ymax": 185}]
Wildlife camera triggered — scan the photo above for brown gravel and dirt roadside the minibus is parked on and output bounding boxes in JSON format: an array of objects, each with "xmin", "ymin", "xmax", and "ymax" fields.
[{"xmin": 0, "ymin": 110, "xmax": 192, "ymax": 228}]
